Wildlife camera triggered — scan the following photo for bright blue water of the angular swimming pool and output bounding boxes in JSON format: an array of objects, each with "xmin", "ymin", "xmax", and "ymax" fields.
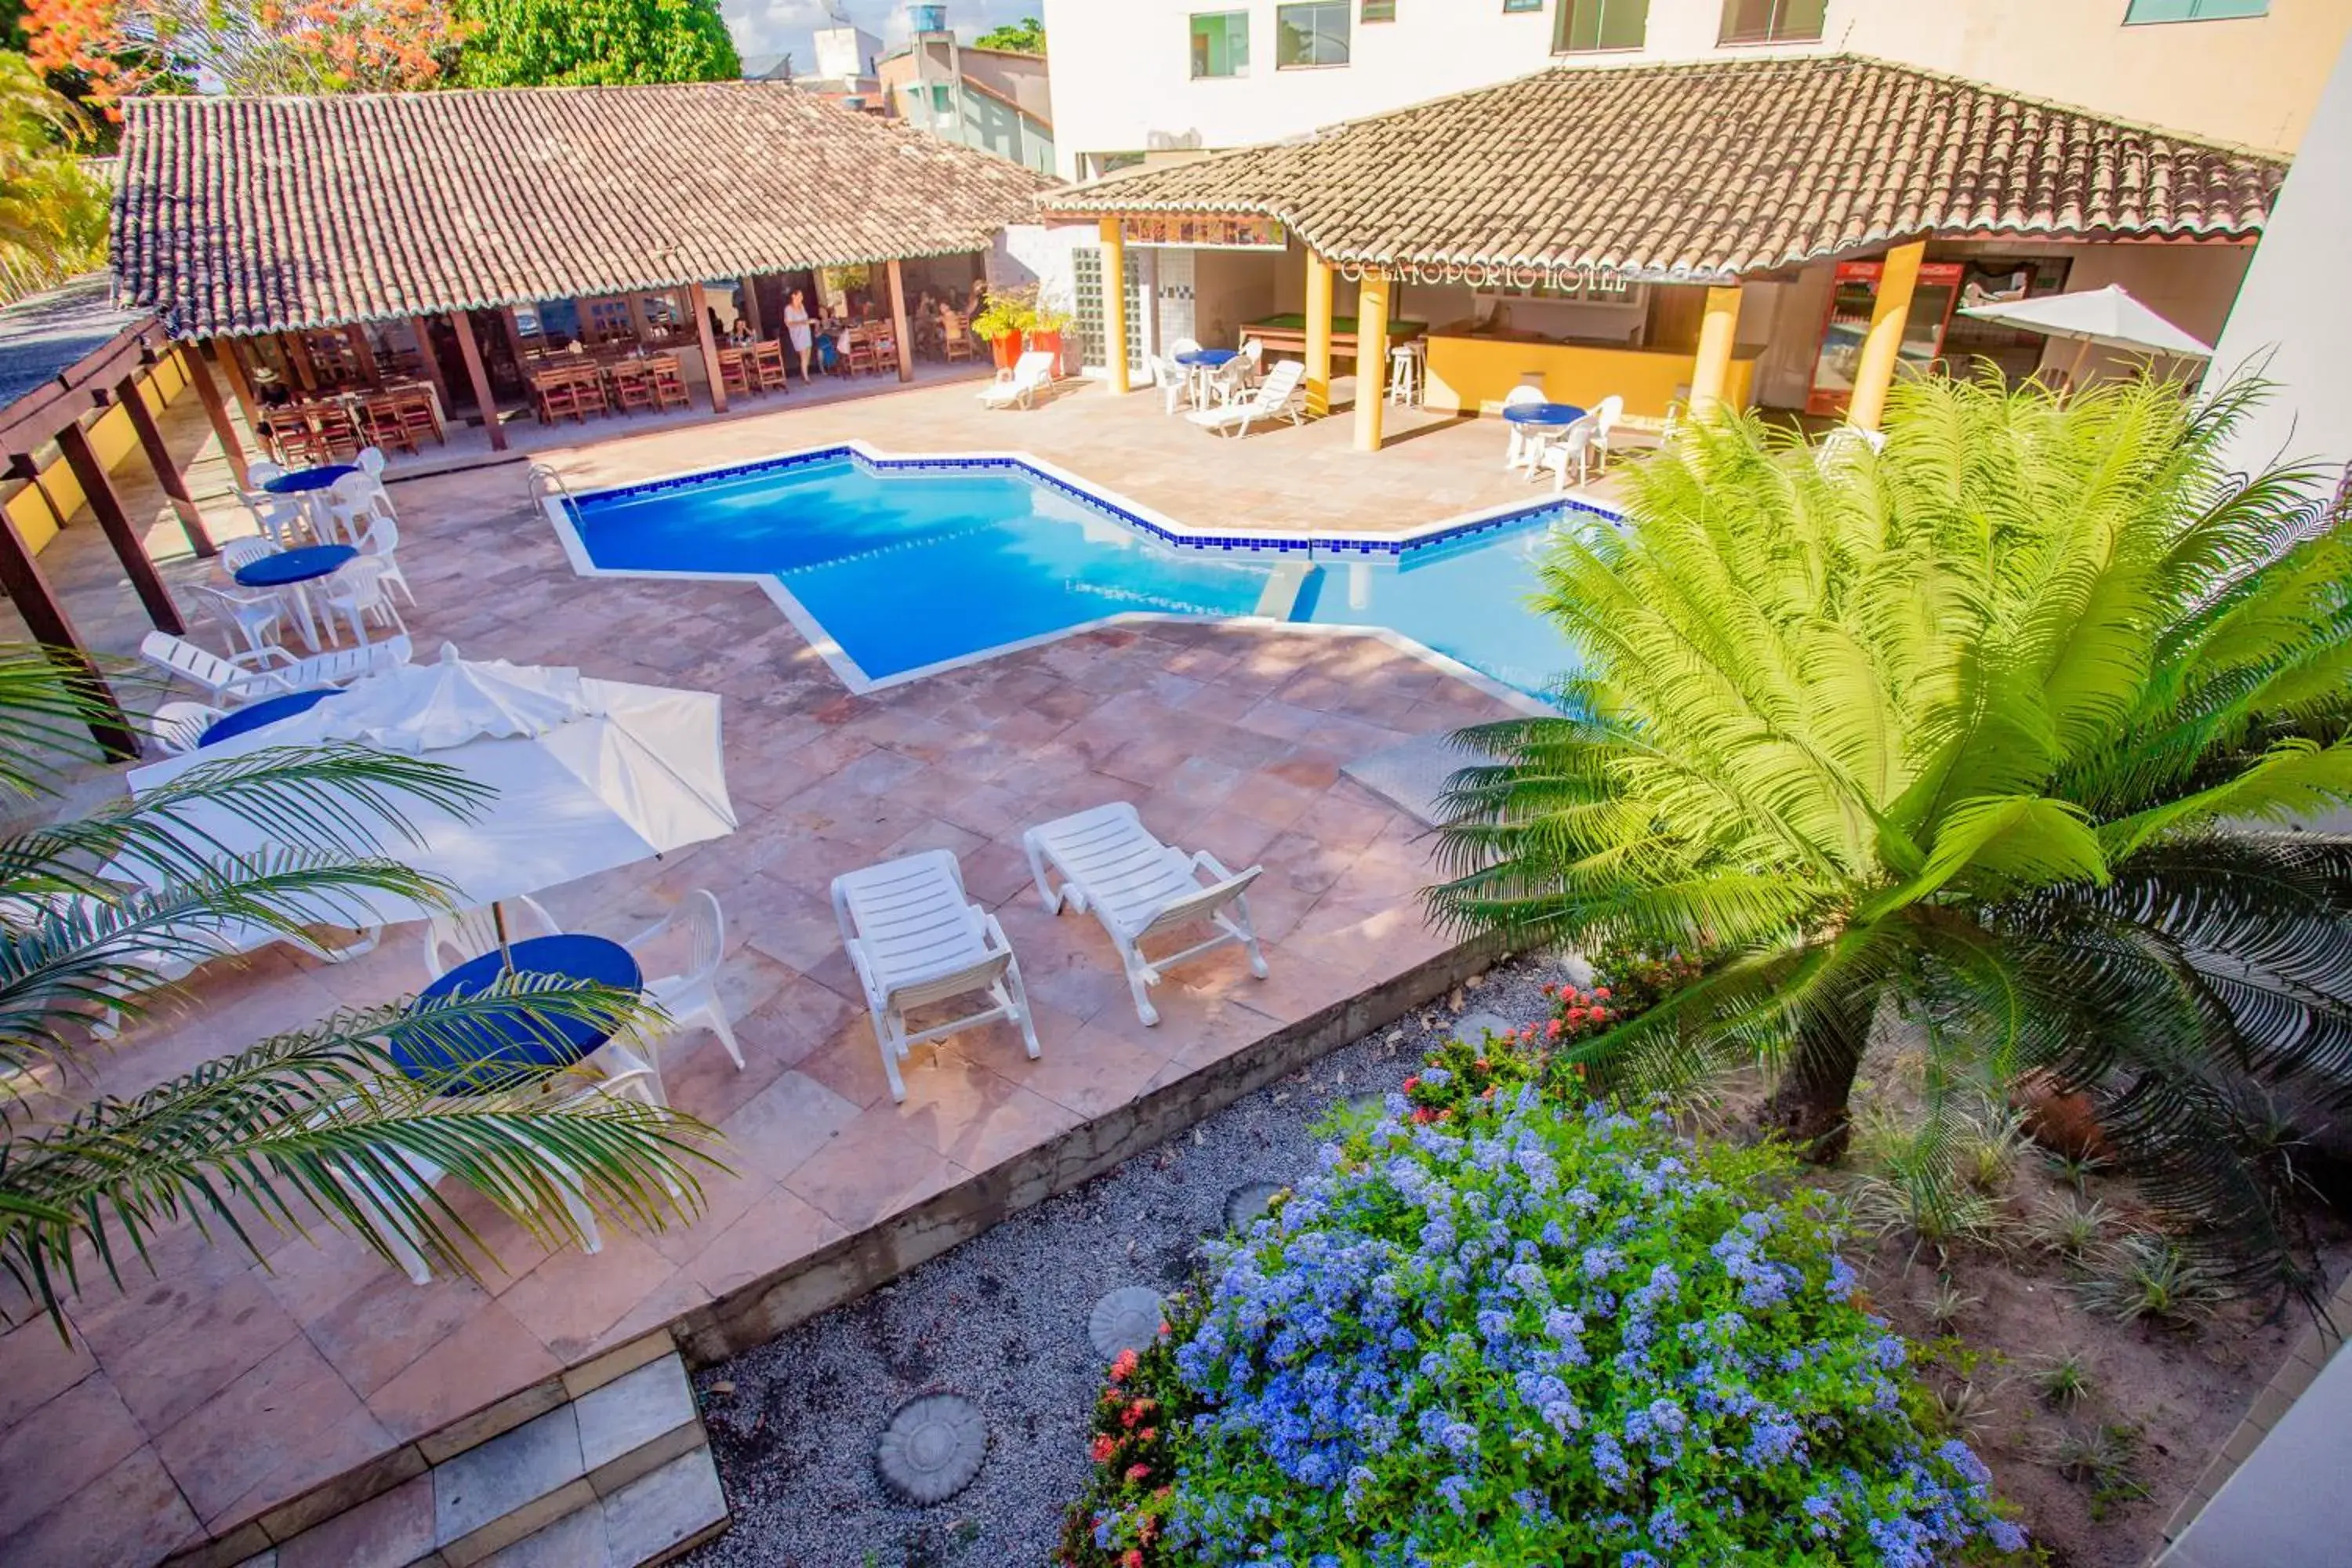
[{"xmin": 574, "ymin": 456, "xmax": 1573, "ymax": 691}]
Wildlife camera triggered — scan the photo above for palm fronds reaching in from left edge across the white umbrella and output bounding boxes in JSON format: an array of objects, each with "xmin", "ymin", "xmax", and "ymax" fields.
[{"xmin": 0, "ymin": 649, "xmax": 710, "ymax": 1330}]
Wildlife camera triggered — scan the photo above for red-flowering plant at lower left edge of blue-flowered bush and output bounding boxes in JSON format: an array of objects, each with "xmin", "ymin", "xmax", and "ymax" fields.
[{"xmin": 1054, "ymin": 1298, "xmax": 1202, "ymax": 1568}]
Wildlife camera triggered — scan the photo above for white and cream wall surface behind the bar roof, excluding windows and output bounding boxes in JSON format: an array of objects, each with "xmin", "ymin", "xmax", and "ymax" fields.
[{"xmin": 1044, "ymin": 0, "xmax": 2352, "ymax": 176}]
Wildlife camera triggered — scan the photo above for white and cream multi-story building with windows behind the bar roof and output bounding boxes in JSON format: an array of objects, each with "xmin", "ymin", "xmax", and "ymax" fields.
[{"xmin": 1044, "ymin": 0, "xmax": 2352, "ymax": 179}]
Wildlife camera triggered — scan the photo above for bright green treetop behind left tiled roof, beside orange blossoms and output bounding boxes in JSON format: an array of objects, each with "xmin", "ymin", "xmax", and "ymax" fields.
[{"xmin": 459, "ymin": 0, "xmax": 743, "ymax": 87}]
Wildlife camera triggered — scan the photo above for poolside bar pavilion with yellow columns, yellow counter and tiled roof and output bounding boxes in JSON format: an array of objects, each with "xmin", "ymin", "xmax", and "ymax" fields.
[{"xmin": 1044, "ymin": 56, "xmax": 2286, "ymax": 452}]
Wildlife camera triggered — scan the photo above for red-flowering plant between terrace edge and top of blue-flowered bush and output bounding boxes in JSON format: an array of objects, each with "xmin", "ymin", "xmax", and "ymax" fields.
[{"xmin": 1404, "ymin": 947, "xmax": 1703, "ymax": 1121}]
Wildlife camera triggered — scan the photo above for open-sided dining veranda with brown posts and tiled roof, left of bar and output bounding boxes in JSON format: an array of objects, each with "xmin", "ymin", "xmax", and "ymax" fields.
[{"xmin": 115, "ymin": 82, "xmax": 1044, "ymax": 482}]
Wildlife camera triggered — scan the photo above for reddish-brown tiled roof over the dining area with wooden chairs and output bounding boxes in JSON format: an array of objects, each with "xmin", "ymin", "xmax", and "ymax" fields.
[{"xmin": 115, "ymin": 82, "xmax": 1049, "ymax": 336}]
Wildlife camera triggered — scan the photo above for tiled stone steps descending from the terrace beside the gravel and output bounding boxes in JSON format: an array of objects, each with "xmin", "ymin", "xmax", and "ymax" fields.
[{"xmin": 240, "ymin": 1349, "xmax": 727, "ymax": 1568}]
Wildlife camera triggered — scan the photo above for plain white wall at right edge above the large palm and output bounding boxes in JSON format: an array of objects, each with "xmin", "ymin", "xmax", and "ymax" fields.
[{"xmin": 2213, "ymin": 36, "xmax": 2352, "ymax": 479}]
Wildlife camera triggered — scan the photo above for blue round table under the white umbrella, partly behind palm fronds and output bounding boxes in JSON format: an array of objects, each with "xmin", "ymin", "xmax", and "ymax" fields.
[{"xmin": 393, "ymin": 933, "xmax": 644, "ymax": 1093}]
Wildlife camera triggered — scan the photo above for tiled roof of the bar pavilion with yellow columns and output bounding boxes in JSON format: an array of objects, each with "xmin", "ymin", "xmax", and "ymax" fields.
[{"xmin": 1044, "ymin": 54, "xmax": 2286, "ymax": 280}]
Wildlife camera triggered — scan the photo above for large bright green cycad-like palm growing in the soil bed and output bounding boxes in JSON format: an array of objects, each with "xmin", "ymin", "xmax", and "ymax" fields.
[{"xmin": 1430, "ymin": 381, "xmax": 2352, "ymax": 1298}]
